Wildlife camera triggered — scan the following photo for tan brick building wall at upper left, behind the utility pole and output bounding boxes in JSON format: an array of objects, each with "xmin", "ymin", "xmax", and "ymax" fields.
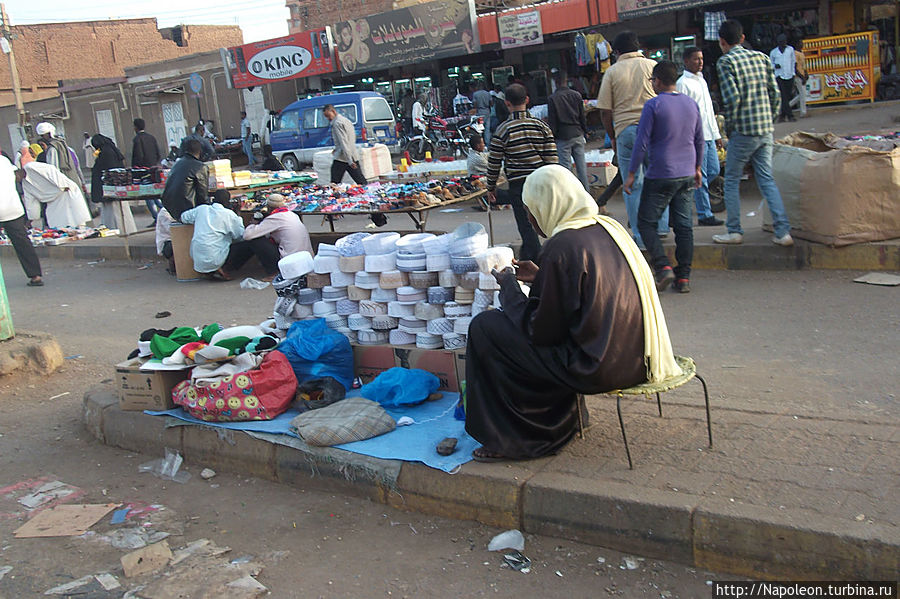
[{"xmin": 0, "ymin": 19, "xmax": 244, "ymax": 106}]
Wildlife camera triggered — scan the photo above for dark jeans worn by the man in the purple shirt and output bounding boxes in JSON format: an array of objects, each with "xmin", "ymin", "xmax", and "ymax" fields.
[{"xmin": 638, "ymin": 177, "xmax": 694, "ymax": 279}]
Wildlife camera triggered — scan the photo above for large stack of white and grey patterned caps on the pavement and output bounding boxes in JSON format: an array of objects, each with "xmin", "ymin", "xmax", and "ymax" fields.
[{"xmin": 273, "ymin": 223, "xmax": 513, "ymax": 349}]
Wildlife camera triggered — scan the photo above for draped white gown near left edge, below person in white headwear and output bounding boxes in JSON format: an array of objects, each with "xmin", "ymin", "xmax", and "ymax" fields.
[{"xmin": 22, "ymin": 162, "xmax": 91, "ymax": 229}]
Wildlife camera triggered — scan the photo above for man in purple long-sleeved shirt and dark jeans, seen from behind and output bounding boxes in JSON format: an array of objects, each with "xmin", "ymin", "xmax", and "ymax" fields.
[{"xmin": 625, "ymin": 60, "xmax": 705, "ymax": 293}]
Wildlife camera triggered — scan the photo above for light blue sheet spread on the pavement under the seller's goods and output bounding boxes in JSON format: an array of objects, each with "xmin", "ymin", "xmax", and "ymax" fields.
[{"xmin": 146, "ymin": 391, "xmax": 480, "ymax": 472}]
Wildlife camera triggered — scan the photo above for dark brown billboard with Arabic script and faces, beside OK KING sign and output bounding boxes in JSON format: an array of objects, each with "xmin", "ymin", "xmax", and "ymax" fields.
[{"xmin": 333, "ymin": 0, "xmax": 481, "ymax": 75}]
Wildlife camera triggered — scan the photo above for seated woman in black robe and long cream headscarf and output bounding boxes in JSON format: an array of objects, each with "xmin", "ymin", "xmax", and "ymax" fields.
[{"xmin": 466, "ymin": 165, "xmax": 674, "ymax": 461}]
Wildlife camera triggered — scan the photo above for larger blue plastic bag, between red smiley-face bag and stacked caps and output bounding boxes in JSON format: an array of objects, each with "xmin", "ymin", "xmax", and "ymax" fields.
[{"xmin": 278, "ymin": 318, "xmax": 353, "ymax": 390}]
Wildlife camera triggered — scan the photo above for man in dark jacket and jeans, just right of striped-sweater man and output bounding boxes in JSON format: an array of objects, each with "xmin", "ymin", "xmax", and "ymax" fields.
[{"xmin": 547, "ymin": 71, "xmax": 590, "ymax": 192}]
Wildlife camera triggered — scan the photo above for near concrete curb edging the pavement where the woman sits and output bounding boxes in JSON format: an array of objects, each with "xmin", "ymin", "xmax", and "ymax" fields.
[{"xmin": 83, "ymin": 387, "xmax": 900, "ymax": 580}]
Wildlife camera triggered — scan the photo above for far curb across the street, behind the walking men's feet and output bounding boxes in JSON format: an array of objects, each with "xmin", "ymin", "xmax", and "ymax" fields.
[{"xmin": 8, "ymin": 239, "xmax": 900, "ymax": 271}]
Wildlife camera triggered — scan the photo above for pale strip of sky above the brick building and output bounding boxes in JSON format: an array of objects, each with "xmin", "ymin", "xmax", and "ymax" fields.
[{"xmin": 5, "ymin": 0, "xmax": 289, "ymax": 42}]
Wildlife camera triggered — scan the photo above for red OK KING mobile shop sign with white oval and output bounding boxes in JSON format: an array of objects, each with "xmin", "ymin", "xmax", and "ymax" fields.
[{"xmin": 223, "ymin": 27, "xmax": 337, "ymax": 87}]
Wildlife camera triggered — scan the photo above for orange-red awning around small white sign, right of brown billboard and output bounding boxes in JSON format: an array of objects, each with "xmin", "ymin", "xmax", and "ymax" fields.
[{"xmin": 478, "ymin": 0, "xmax": 618, "ymax": 45}]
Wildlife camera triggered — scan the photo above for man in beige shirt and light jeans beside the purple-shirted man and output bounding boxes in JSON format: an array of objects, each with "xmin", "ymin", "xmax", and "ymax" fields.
[{"xmin": 597, "ymin": 31, "xmax": 669, "ymax": 249}]
